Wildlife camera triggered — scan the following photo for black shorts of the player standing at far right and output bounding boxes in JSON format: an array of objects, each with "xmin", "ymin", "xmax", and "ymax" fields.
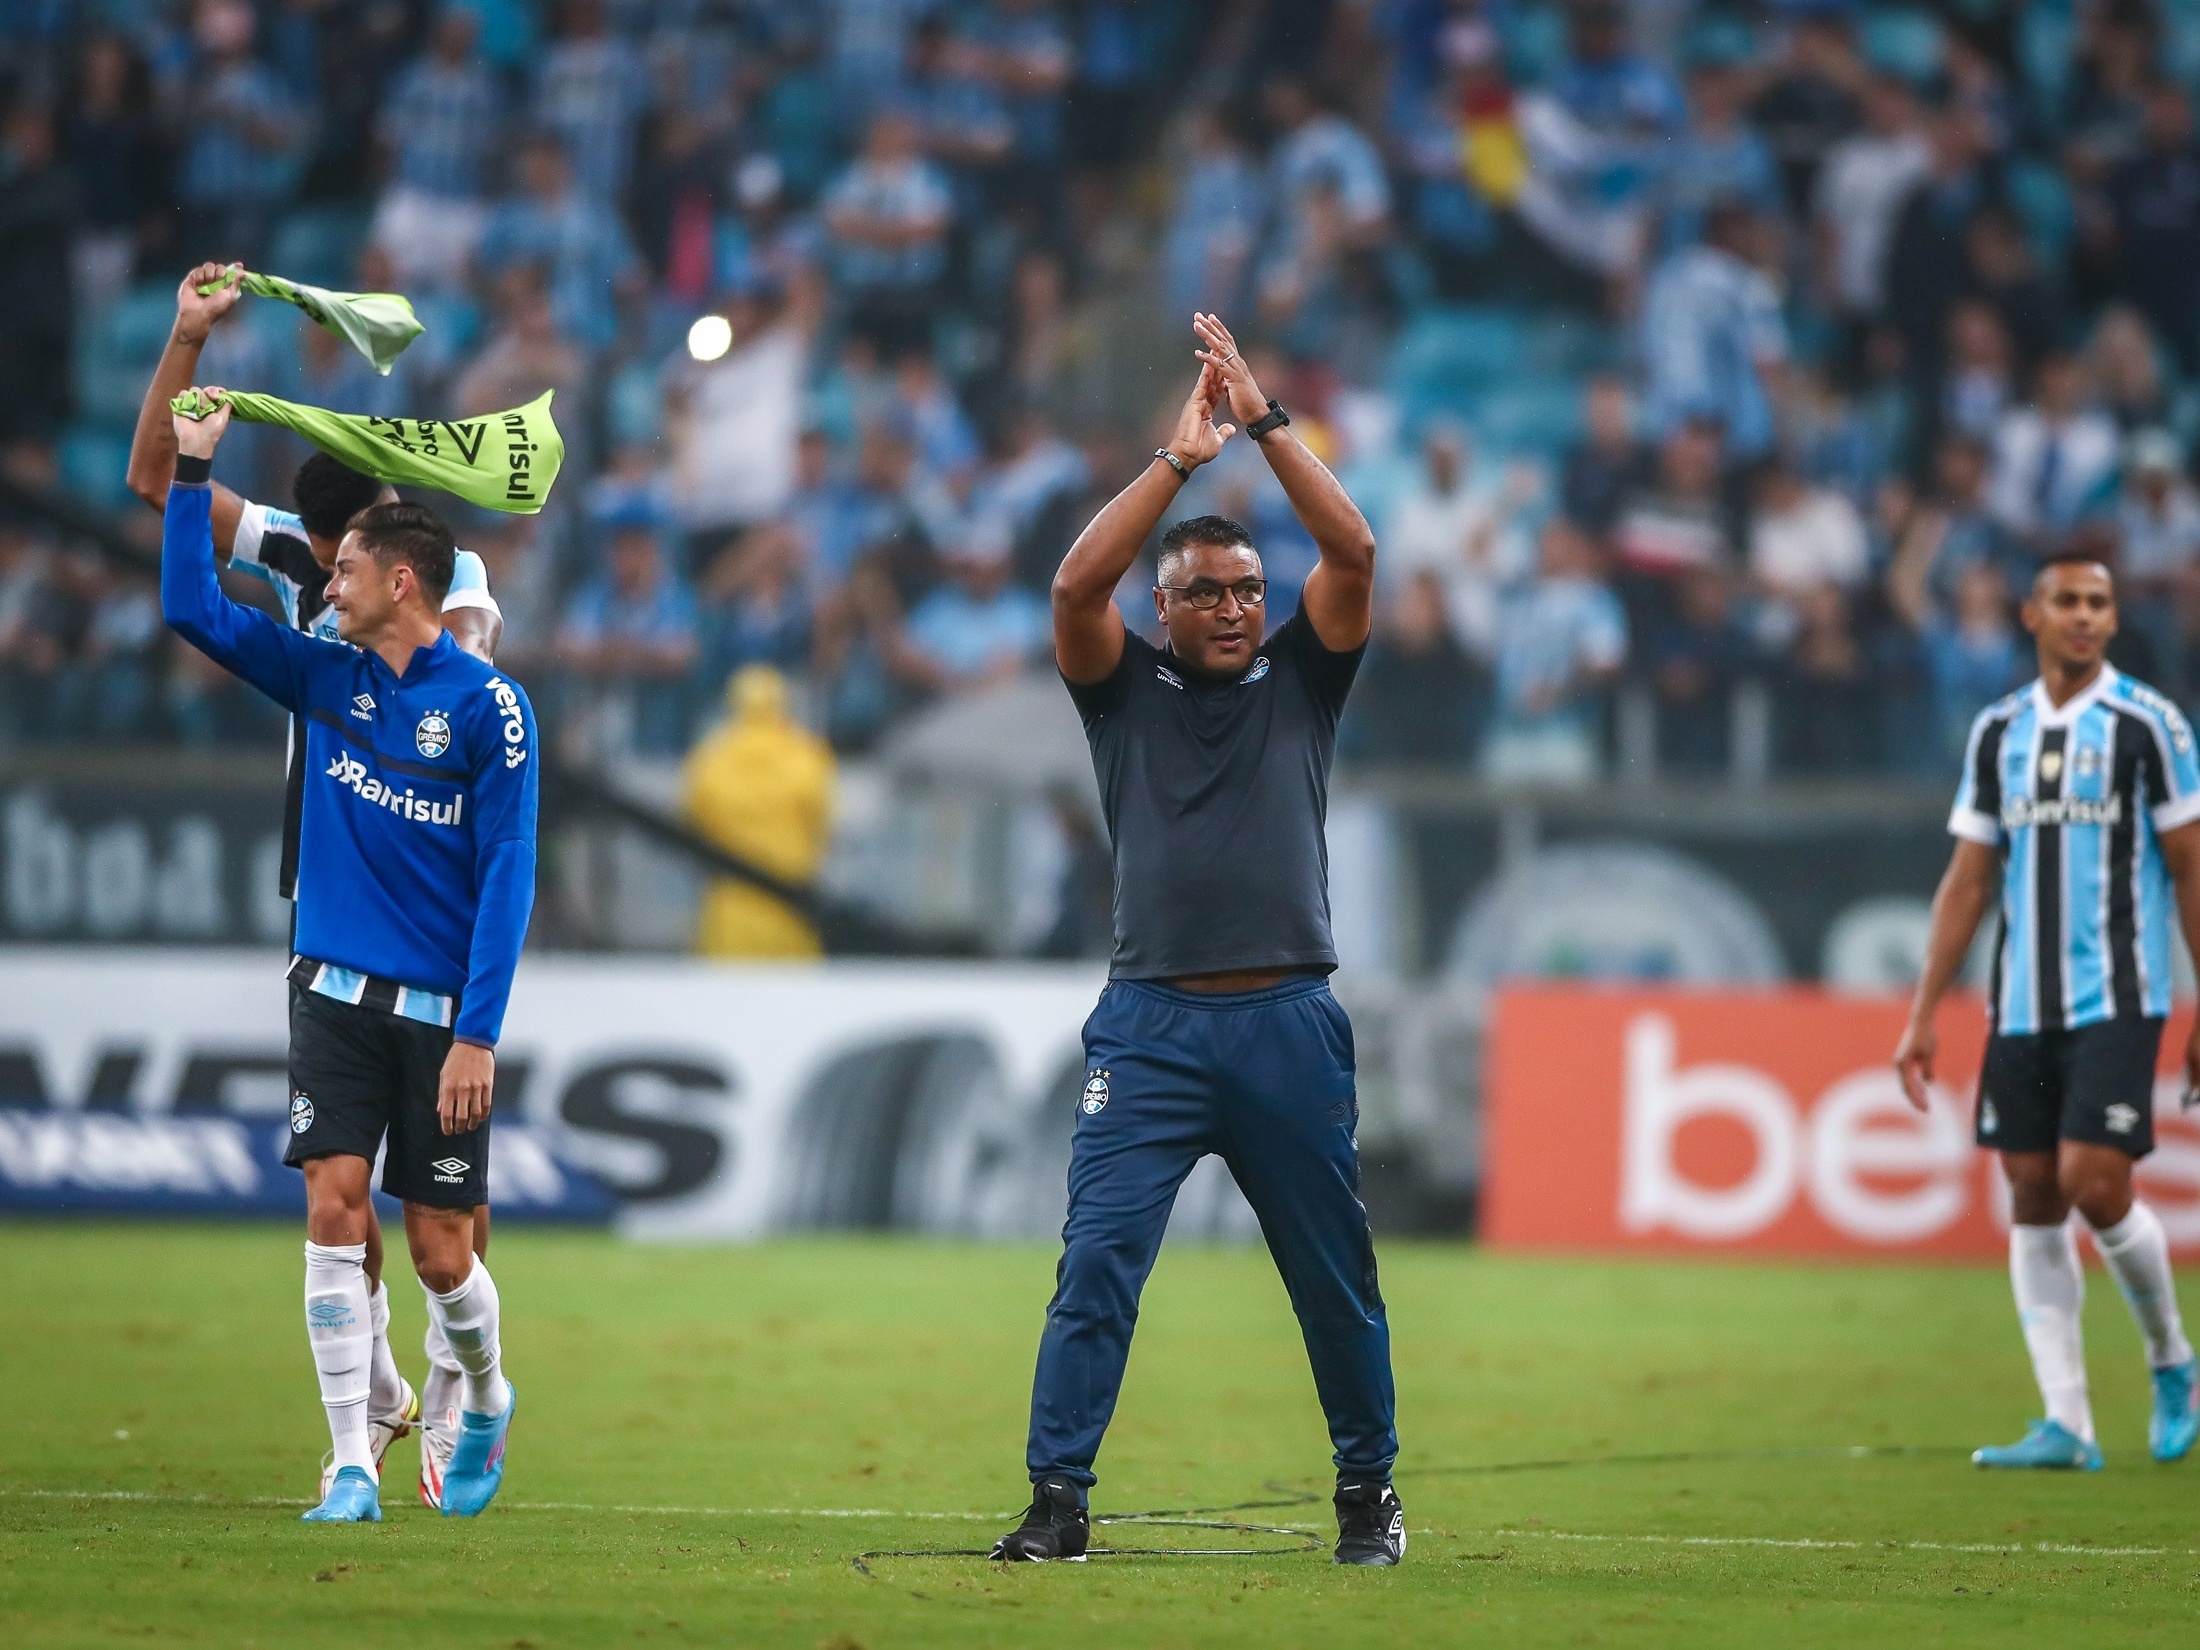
[{"xmin": 1978, "ymin": 1016, "xmax": 2163, "ymax": 1157}]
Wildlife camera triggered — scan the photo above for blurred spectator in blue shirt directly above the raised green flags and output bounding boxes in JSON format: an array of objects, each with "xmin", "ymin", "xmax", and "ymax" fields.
[{"xmin": 178, "ymin": 0, "xmax": 312, "ymax": 268}]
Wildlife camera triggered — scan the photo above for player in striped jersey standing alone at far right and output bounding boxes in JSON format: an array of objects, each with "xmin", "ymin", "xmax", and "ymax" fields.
[{"xmin": 1894, "ymin": 552, "xmax": 2200, "ymax": 1472}]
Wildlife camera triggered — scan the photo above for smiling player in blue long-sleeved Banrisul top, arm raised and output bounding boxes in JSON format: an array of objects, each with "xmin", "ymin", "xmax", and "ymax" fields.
[{"xmin": 161, "ymin": 389, "xmax": 537, "ymax": 1522}]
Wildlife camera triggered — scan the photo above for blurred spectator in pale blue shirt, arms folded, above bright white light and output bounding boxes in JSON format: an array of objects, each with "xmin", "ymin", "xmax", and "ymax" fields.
[{"xmin": 825, "ymin": 110, "xmax": 950, "ymax": 361}]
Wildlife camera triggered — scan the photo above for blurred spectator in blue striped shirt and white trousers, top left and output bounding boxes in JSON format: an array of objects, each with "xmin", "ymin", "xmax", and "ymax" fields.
[{"xmin": 374, "ymin": 4, "xmax": 504, "ymax": 290}]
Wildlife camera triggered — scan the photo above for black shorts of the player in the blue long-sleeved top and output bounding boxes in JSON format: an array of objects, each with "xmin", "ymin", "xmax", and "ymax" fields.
[{"xmin": 282, "ymin": 986, "xmax": 488, "ymax": 1208}]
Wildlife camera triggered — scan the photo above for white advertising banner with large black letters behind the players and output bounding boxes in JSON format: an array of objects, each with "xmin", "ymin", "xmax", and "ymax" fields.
[{"xmin": 0, "ymin": 948, "xmax": 1252, "ymax": 1239}]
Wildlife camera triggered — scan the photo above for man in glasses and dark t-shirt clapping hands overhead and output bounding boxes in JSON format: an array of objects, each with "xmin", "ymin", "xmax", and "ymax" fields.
[{"xmin": 992, "ymin": 315, "xmax": 1406, "ymax": 1564}]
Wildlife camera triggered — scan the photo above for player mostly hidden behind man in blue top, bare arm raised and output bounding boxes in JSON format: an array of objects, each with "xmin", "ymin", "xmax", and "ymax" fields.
[{"xmin": 130, "ymin": 264, "xmax": 504, "ymax": 1507}]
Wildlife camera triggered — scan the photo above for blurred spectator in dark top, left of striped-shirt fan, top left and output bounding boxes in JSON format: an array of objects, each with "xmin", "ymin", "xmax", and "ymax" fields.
[{"xmin": 62, "ymin": 33, "xmax": 172, "ymax": 315}]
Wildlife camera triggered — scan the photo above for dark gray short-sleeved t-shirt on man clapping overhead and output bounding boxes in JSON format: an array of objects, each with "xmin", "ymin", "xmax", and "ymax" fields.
[{"xmin": 1069, "ymin": 612, "xmax": 1366, "ymax": 979}]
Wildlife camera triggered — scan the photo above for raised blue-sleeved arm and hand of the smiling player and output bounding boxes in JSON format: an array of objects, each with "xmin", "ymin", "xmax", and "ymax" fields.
[{"xmin": 161, "ymin": 389, "xmax": 317, "ymax": 711}]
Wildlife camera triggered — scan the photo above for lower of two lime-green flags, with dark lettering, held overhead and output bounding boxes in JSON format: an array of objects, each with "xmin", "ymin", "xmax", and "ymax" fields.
[{"xmin": 169, "ymin": 389, "xmax": 565, "ymax": 515}]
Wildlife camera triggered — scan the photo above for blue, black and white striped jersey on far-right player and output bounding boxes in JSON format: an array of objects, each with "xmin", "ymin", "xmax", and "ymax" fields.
[{"xmin": 1947, "ymin": 664, "xmax": 2200, "ymax": 1036}]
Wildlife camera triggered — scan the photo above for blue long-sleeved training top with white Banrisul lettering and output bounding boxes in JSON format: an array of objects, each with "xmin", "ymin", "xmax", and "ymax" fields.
[{"xmin": 161, "ymin": 484, "xmax": 539, "ymax": 1047}]
